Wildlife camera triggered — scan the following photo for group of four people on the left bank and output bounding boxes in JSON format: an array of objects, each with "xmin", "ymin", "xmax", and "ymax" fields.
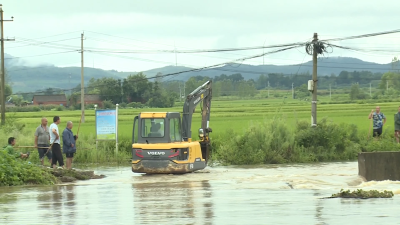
[{"xmin": 4, "ymin": 116, "xmax": 78, "ymax": 169}]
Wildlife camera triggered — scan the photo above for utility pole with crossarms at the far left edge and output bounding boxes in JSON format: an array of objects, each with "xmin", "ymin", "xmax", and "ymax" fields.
[{"xmin": 0, "ymin": 4, "xmax": 15, "ymax": 125}]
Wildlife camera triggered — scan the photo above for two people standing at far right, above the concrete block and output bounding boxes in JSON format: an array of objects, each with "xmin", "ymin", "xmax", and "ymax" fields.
[{"xmin": 368, "ymin": 106, "xmax": 400, "ymax": 143}]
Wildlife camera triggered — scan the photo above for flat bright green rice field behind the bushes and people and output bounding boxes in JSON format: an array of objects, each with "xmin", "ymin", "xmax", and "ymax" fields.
[{"xmin": 7, "ymin": 99, "xmax": 399, "ymax": 139}]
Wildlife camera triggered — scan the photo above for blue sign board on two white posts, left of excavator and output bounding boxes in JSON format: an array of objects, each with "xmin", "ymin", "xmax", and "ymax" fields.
[{"xmin": 95, "ymin": 104, "xmax": 118, "ymax": 154}]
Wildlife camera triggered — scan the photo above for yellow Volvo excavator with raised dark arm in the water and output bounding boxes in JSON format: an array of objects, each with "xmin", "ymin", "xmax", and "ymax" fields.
[{"xmin": 132, "ymin": 80, "xmax": 212, "ymax": 174}]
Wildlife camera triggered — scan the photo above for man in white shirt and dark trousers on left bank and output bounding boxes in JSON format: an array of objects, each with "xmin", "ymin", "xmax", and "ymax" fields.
[{"xmin": 50, "ymin": 116, "xmax": 64, "ymax": 169}]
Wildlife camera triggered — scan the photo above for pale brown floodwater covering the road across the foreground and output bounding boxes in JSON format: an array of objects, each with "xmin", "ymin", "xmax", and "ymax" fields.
[{"xmin": 0, "ymin": 162, "xmax": 400, "ymax": 224}]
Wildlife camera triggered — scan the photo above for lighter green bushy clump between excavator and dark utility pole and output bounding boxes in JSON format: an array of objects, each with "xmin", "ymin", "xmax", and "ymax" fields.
[{"xmin": 213, "ymin": 117, "xmax": 295, "ymax": 165}]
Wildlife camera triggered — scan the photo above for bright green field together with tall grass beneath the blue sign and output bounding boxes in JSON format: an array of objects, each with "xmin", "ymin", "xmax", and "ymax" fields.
[{"xmin": 0, "ymin": 96, "xmax": 399, "ymax": 165}]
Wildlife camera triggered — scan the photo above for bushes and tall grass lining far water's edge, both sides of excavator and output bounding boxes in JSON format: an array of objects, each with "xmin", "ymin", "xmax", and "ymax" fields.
[{"xmin": 0, "ymin": 115, "xmax": 400, "ymax": 169}]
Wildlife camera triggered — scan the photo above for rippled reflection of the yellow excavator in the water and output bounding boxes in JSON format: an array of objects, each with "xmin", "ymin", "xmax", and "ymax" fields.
[{"xmin": 132, "ymin": 178, "xmax": 214, "ymax": 224}]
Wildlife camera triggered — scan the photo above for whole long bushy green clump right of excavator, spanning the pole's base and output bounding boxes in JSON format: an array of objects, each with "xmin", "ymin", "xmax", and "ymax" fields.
[{"xmin": 213, "ymin": 116, "xmax": 361, "ymax": 165}]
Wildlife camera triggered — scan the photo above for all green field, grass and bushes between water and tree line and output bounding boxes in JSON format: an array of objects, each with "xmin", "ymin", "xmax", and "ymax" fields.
[{"xmin": 0, "ymin": 95, "xmax": 399, "ymax": 167}]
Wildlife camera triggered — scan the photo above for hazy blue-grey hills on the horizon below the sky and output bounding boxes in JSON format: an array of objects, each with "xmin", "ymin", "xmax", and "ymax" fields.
[{"xmin": 5, "ymin": 54, "xmax": 391, "ymax": 92}]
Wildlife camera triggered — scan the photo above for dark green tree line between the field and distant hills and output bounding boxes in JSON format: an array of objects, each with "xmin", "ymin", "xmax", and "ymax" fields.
[{"xmin": 6, "ymin": 68, "xmax": 400, "ymax": 107}]
